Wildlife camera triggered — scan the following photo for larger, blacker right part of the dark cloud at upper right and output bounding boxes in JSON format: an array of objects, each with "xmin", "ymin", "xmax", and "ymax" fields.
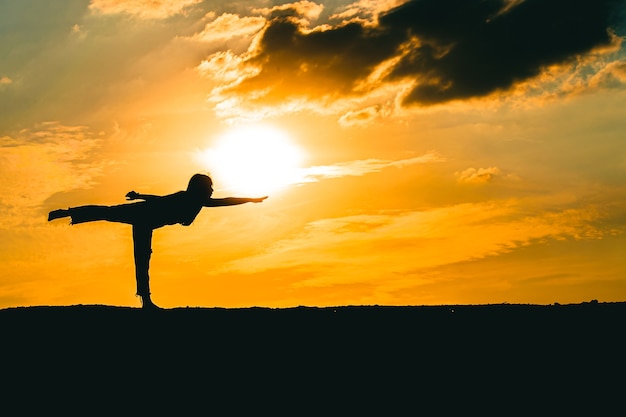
[{"xmin": 381, "ymin": 0, "xmax": 618, "ymax": 103}]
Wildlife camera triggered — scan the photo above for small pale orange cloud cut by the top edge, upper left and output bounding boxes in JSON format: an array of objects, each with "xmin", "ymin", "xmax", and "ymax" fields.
[{"xmin": 89, "ymin": 0, "xmax": 201, "ymax": 19}]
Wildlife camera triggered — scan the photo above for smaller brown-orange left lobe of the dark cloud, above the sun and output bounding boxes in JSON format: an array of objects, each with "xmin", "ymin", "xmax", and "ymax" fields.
[{"xmin": 239, "ymin": 18, "xmax": 395, "ymax": 100}]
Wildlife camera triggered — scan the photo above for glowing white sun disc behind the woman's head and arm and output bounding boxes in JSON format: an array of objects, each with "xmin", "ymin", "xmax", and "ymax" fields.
[{"xmin": 198, "ymin": 125, "xmax": 303, "ymax": 197}]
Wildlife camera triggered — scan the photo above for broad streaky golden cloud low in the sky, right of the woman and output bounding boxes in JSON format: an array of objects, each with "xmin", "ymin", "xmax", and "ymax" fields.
[{"xmin": 225, "ymin": 200, "xmax": 623, "ymax": 286}]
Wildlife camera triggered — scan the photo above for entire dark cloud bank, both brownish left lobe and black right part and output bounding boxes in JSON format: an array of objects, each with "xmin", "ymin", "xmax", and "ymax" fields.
[{"xmin": 233, "ymin": 0, "xmax": 624, "ymax": 105}]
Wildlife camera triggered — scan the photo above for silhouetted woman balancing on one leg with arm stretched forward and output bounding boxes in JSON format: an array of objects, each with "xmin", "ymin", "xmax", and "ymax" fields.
[{"xmin": 48, "ymin": 174, "xmax": 267, "ymax": 309}]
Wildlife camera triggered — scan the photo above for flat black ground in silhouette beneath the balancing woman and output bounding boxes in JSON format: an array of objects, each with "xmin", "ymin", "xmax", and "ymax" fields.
[{"xmin": 0, "ymin": 302, "xmax": 626, "ymax": 416}]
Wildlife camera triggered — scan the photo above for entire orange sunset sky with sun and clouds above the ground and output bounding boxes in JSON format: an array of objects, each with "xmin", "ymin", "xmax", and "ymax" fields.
[{"xmin": 0, "ymin": 0, "xmax": 626, "ymax": 308}]
